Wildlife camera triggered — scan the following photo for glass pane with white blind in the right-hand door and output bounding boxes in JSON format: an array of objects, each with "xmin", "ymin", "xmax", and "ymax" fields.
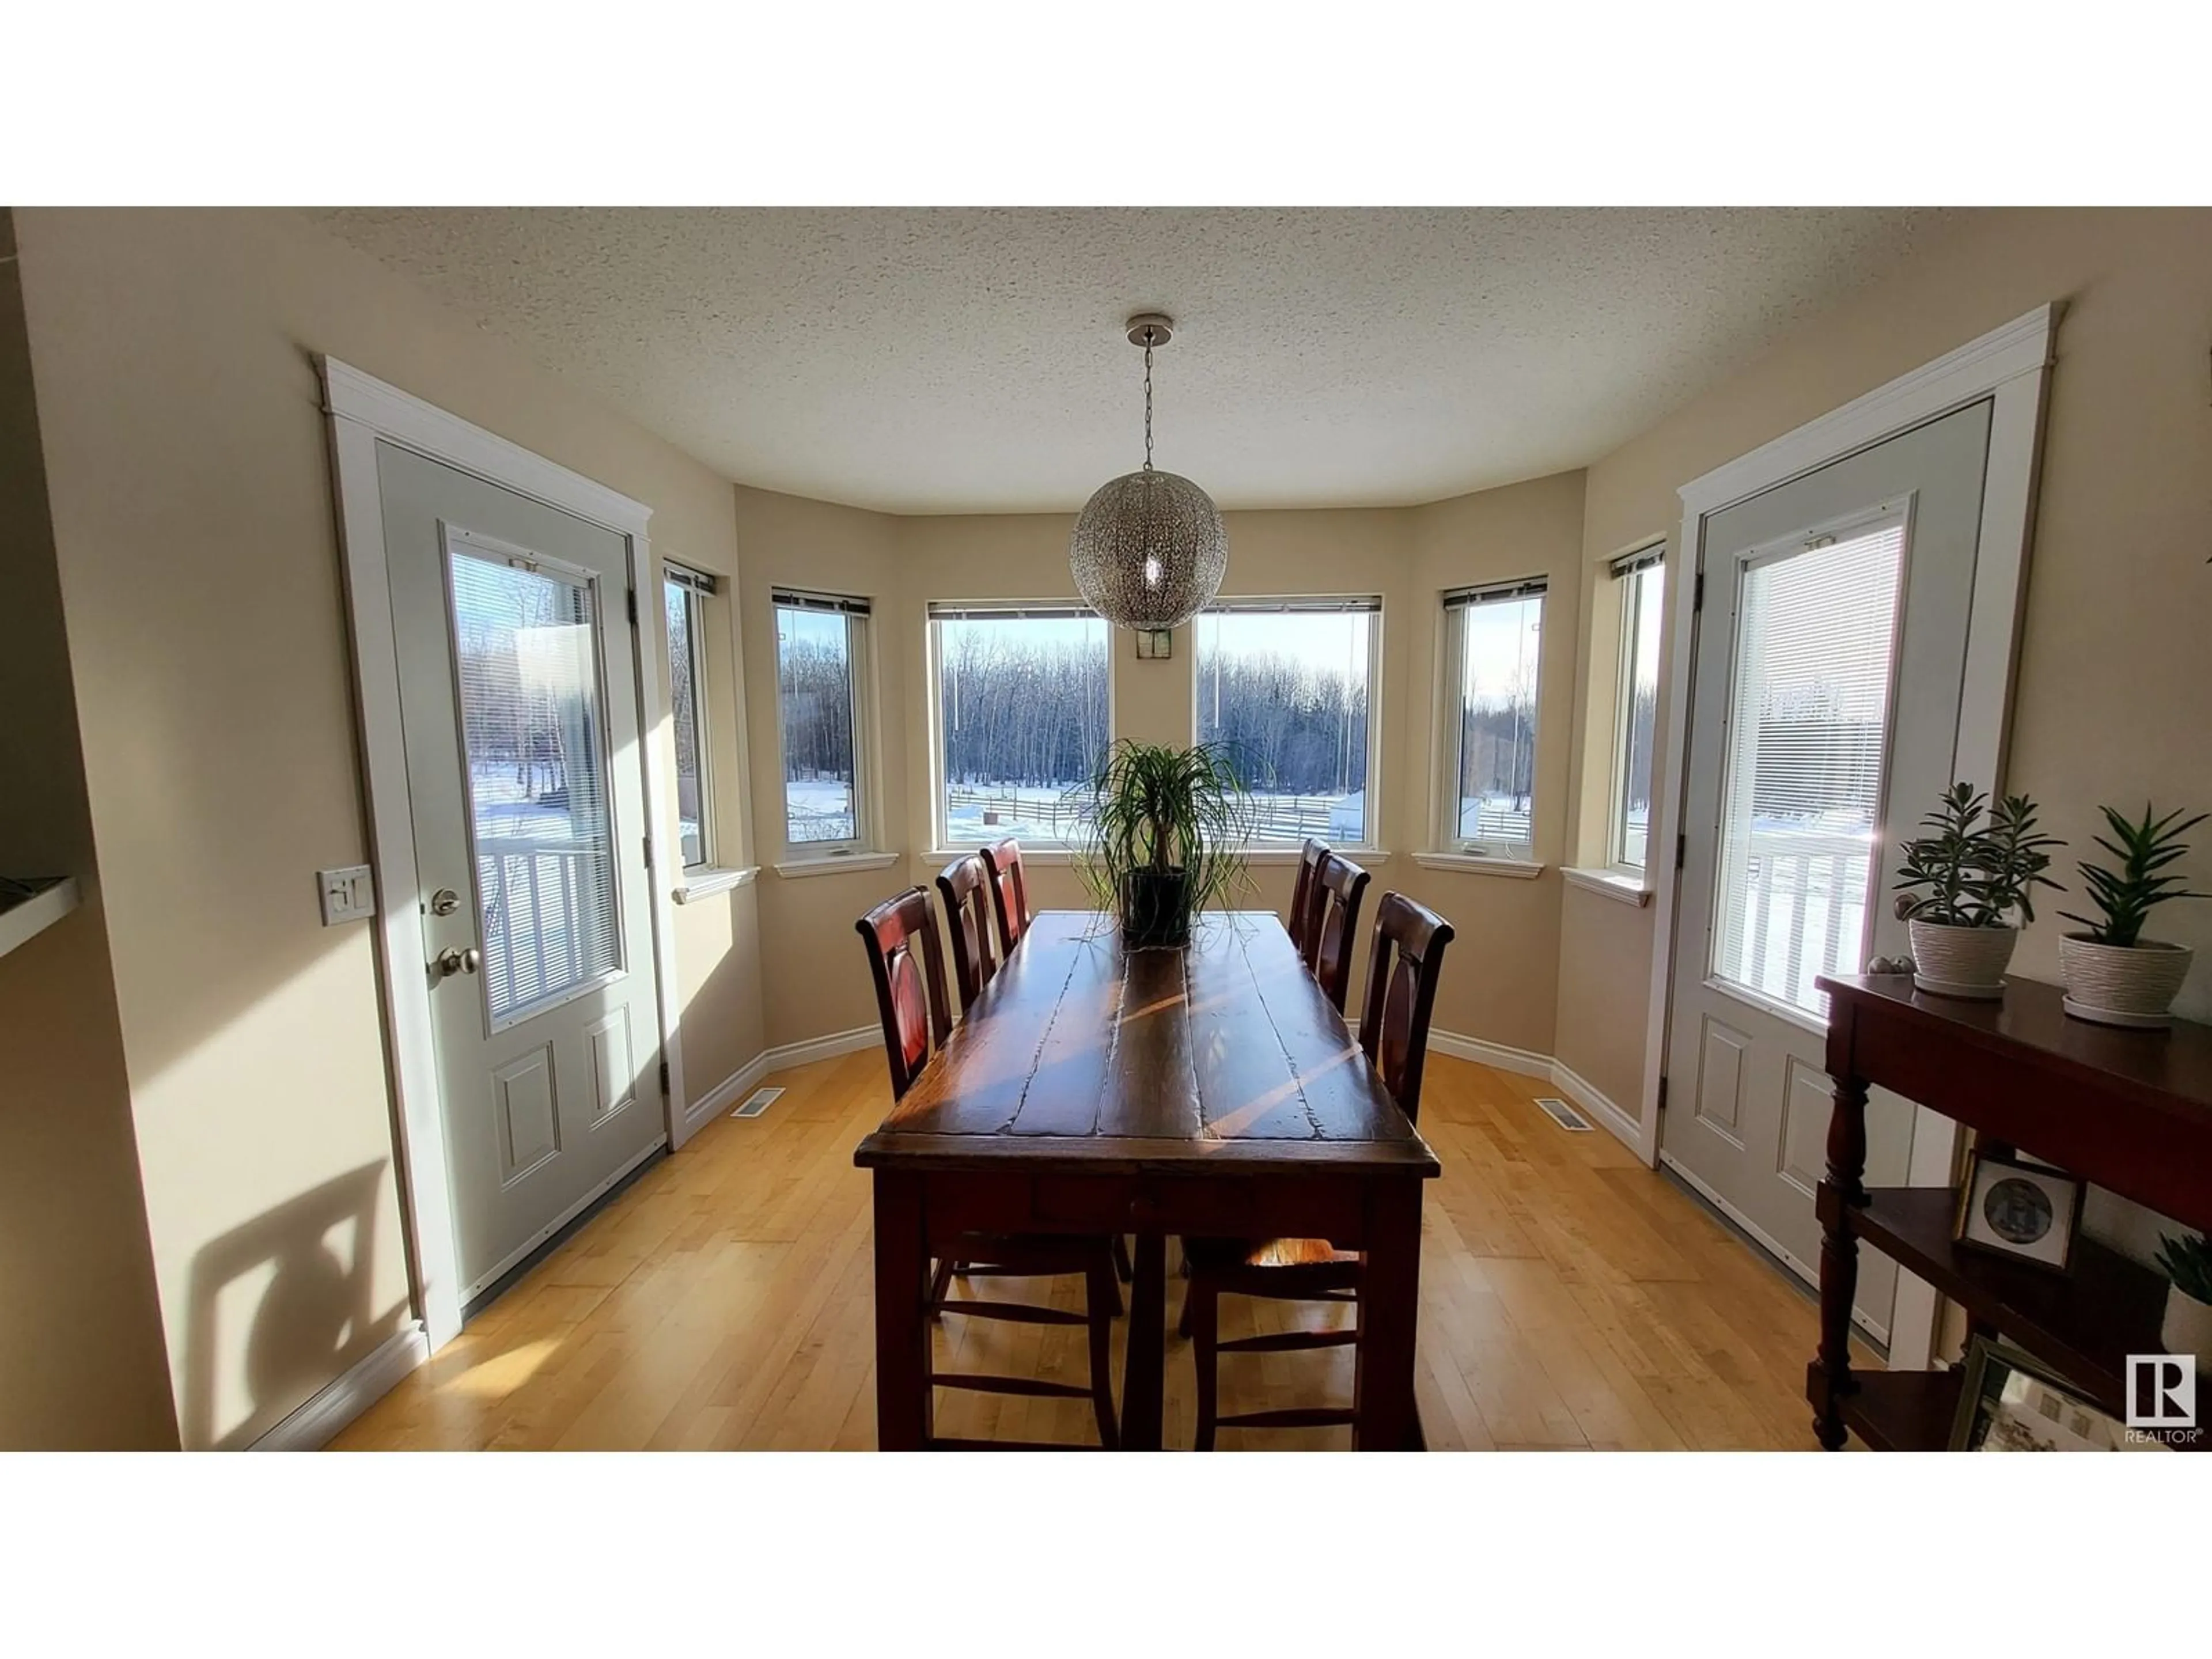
[{"xmin": 1712, "ymin": 513, "xmax": 1904, "ymax": 1013}]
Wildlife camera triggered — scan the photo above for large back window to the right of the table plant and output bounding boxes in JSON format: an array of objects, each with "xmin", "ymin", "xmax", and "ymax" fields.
[{"xmin": 1196, "ymin": 600, "xmax": 1382, "ymax": 847}]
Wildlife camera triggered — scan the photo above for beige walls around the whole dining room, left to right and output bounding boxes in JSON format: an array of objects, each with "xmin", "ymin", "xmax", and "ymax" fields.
[{"xmin": 26, "ymin": 210, "xmax": 2212, "ymax": 1445}]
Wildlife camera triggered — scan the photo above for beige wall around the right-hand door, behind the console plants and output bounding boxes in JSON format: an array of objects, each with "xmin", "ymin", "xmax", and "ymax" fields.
[{"xmin": 1557, "ymin": 210, "xmax": 2212, "ymax": 1141}]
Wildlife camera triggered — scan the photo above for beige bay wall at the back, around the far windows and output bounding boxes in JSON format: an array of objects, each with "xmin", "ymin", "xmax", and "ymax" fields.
[{"xmin": 739, "ymin": 486, "xmax": 1582, "ymax": 1053}]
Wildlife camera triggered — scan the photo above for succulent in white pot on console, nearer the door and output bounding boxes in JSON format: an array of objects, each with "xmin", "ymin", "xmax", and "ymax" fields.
[{"xmin": 1898, "ymin": 783, "xmax": 2066, "ymax": 1000}]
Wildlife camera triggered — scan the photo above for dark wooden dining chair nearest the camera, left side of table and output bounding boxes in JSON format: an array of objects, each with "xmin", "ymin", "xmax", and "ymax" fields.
[{"xmin": 854, "ymin": 887, "xmax": 1122, "ymax": 1449}]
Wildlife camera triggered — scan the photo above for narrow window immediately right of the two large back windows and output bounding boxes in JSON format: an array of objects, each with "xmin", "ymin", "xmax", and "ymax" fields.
[{"xmin": 1442, "ymin": 577, "xmax": 1544, "ymax": 858}]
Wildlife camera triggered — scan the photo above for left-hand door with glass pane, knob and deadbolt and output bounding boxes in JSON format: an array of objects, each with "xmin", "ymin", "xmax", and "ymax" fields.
[{"xmin": 376, "ymin": 442, "xmax": 666, "ymax": 1303}]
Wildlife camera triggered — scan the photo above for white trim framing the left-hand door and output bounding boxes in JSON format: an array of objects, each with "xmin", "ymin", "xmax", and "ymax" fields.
[{"xmin": 316, "ymin": 356, "xmax": 684, "ymax": 1351}]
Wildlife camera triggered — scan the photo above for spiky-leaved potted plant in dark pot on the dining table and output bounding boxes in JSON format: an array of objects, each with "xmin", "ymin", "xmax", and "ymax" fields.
[{"xmin": 1075, "ymin": 739, "xmax": 1250, "ymax": 947}]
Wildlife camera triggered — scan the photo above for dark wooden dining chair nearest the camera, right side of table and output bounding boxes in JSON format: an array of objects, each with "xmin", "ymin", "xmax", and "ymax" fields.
[{"xmin": 1177, "ymin": 893, "xmax": 1451, "ymax": 1451}]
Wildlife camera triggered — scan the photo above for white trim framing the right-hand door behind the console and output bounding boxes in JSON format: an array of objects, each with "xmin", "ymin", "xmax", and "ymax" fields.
[{"xmin": 1637, "ymin": 303, "xmax": 2062, "ymax": 1369}]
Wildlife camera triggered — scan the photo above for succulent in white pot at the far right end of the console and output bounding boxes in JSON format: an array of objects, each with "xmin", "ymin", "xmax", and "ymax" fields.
[{"xmin": 2059, "ymin": 801, "xmax": 2212, "ymax": 1029}]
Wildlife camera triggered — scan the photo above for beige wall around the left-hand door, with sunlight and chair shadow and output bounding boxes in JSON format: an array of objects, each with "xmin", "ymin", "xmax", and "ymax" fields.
[{"xmin": 18, "ymin": 210, "xmax": 756, "ymax": 1445}]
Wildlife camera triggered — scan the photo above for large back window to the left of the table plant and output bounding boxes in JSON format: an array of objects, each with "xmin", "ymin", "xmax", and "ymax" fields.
[{"xmin": 929, "ymin": 604, "xmax": 1113, "ymax": 847}]
